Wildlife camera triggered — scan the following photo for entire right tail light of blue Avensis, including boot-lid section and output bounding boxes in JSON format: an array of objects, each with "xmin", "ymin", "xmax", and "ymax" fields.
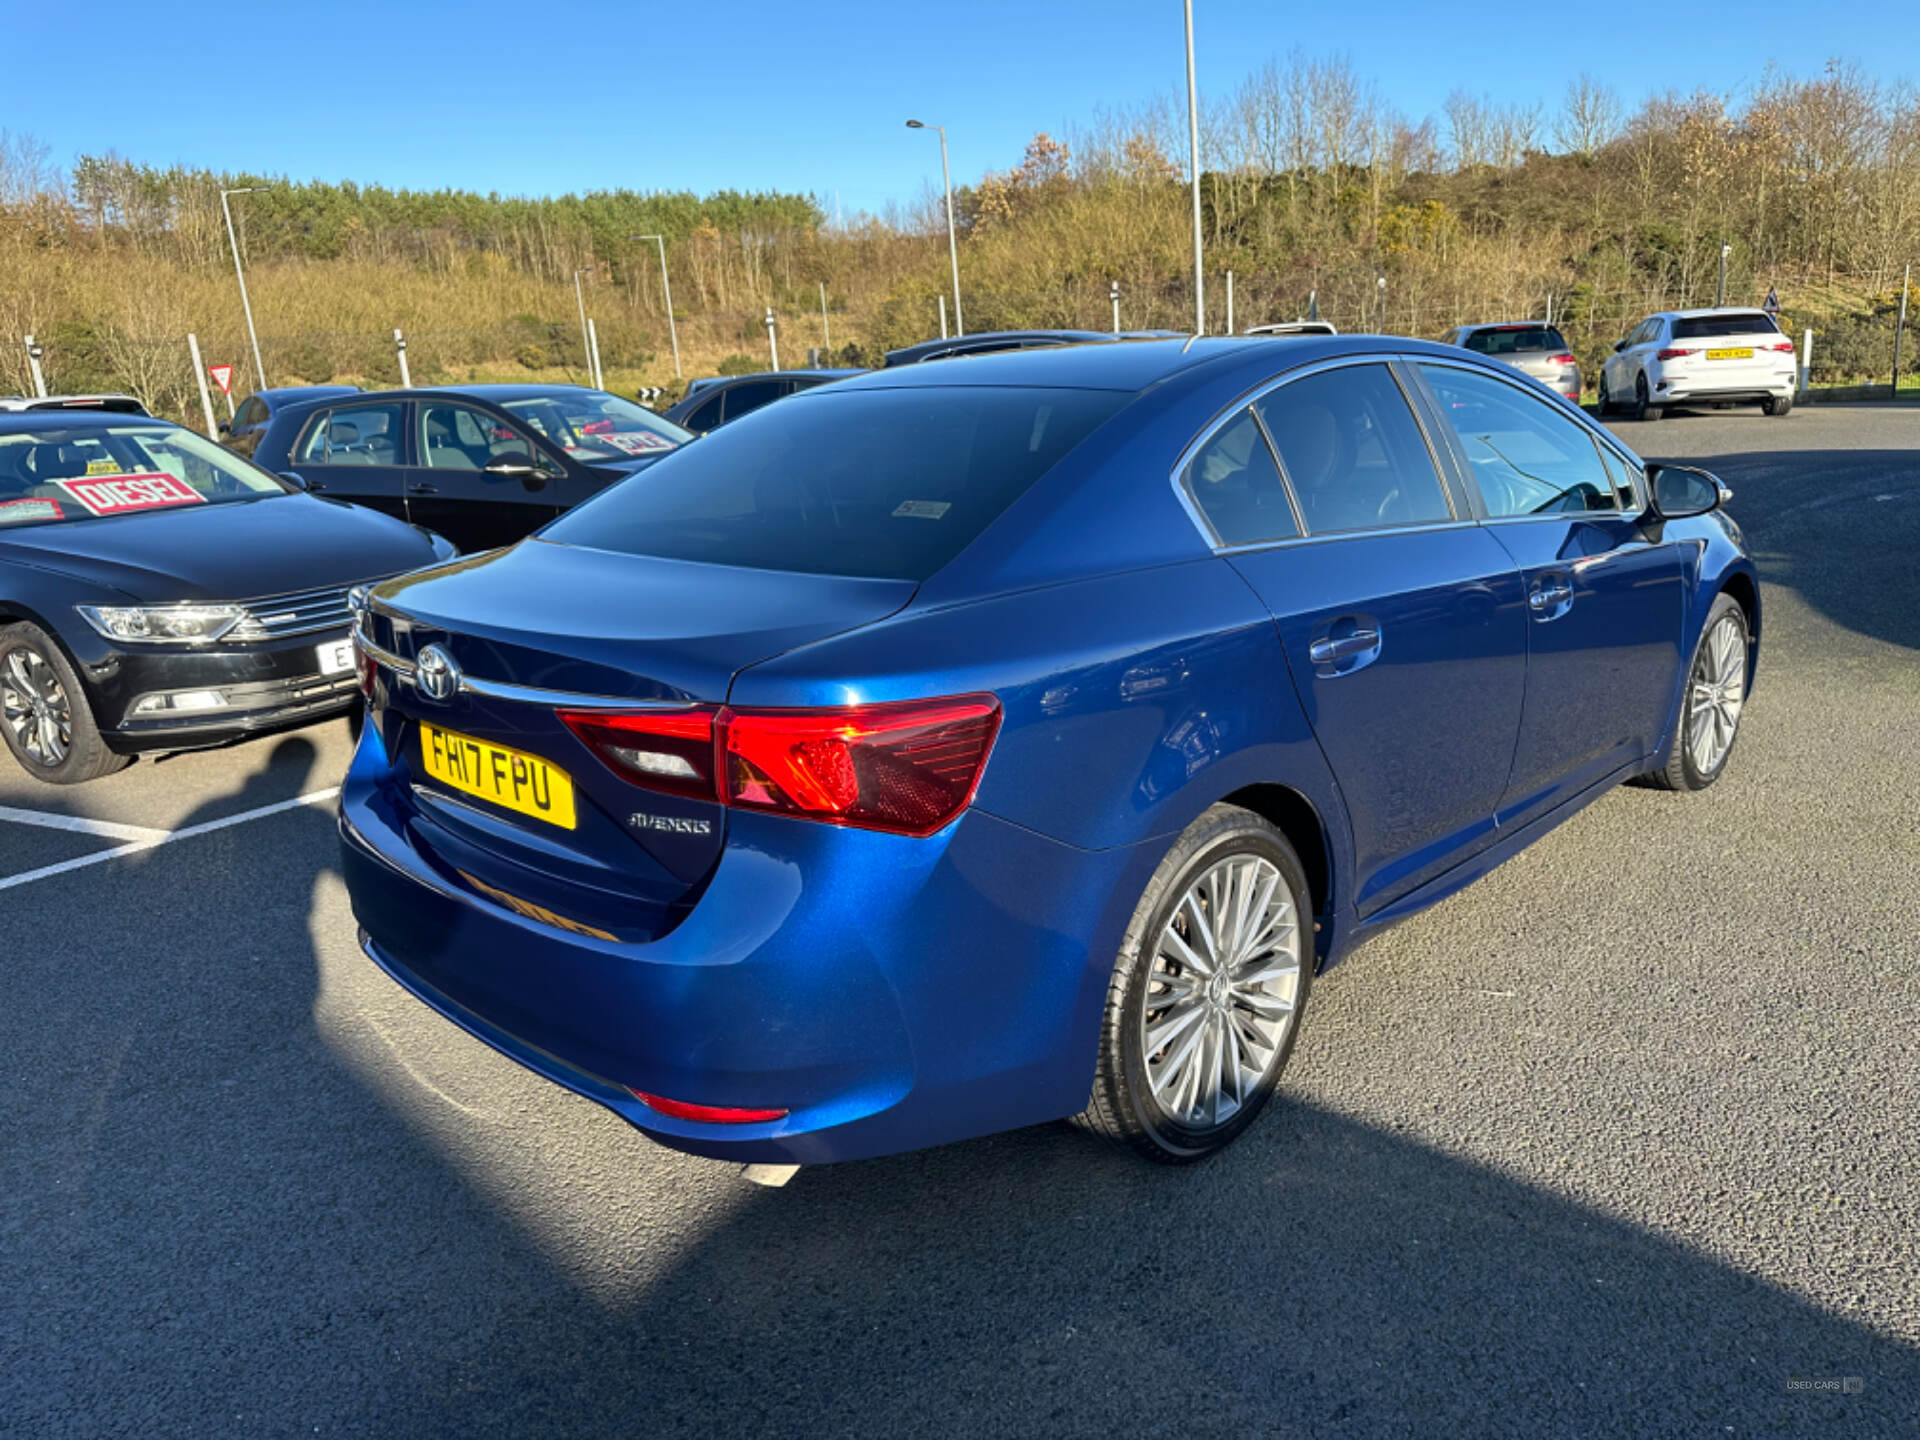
[{"xmin": 561, "ymin": 695, "xmax": 1000, "ymax": 835}]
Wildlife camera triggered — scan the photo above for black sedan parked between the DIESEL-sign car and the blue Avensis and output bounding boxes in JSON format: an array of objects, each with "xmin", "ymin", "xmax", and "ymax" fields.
[{"xmin": 253, "ymin": 386, "xmax": 691, "ymax": 551}]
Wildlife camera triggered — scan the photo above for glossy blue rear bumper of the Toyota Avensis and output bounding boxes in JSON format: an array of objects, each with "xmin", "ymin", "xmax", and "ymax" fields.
[{"xmin": 340, "ymin": 726, "xmax": 1158, "ymax": 1164}]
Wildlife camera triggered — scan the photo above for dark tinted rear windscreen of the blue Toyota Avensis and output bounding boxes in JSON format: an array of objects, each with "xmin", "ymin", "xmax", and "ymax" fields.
[{"xmin": 541, "ymin": 386, "xmax": 1133, "ymax": 580}]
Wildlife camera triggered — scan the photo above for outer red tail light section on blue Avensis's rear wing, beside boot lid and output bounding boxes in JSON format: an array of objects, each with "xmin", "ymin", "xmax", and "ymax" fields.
[{"xmin": 720, "ymin": 695, "xmax": 1000, "ymax": 835}]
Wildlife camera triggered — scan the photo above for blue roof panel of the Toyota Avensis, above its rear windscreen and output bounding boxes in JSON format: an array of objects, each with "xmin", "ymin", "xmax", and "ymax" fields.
[{"xmin": 817, "ymin": 334, "xmax": 1420, "ymax": 403}]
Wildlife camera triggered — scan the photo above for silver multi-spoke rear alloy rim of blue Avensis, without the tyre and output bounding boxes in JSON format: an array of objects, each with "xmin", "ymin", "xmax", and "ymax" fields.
[{"xmin": 1140, "ymin": 852, "xmax": 1300, "ymax": 1129}]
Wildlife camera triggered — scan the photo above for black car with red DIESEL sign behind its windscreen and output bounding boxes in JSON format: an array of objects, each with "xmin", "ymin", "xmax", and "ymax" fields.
[{"xmin": 0, "ymin": 413, "xmax": 455, "ymax": 785}]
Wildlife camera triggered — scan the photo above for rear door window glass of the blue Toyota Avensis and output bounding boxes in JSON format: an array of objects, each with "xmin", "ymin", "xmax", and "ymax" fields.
[{"xmin": 1254, "ymin": 365, "xmax": 1453, "ymax": 536}]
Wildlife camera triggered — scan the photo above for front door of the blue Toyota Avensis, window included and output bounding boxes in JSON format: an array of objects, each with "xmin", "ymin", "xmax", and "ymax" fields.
[{"xmin": 1419, "ymin": 361, "xmax": 1684, "ymax": 826}]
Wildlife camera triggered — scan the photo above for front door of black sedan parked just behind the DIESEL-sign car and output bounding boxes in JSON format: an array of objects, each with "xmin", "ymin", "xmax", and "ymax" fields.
[{"xmin": 407, "ymin": 399, "xmax": 564, "ymax": 551}]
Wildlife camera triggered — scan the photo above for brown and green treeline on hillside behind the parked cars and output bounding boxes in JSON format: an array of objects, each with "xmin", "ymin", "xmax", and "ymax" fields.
[{"xmin": 0, "ymin": 54, "xmax": 1920, "ymax": 420}]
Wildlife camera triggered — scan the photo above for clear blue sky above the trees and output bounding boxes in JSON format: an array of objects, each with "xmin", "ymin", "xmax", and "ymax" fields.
[{"xmin": 0, "ymin": 0, "xmax": 1920, "ymax": 213}]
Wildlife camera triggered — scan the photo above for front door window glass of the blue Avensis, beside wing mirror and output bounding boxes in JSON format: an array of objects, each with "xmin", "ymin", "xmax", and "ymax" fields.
[{"xmin": 1421, "ymin": 365, "xmax": 1620, "ymax": 520}]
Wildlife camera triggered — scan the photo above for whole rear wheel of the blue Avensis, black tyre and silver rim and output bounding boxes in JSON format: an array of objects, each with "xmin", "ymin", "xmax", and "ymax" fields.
[{"xmin": 1079, "ymin": 804, "xmax": 1313, "ymax": 1165}]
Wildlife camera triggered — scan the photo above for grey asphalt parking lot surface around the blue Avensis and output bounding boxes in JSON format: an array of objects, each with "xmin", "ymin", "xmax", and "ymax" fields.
[{"xmin": 0, "ymin": 407, "xmax": 1920, "ymax": 1436}]
